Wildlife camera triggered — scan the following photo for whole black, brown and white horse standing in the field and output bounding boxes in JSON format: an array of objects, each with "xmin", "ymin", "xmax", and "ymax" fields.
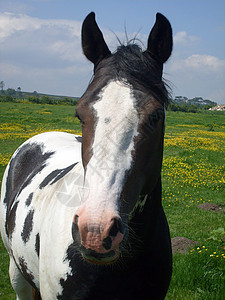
[{"xmin": 0, "ymin": 12, "xmax": 173, "ymax": 300}]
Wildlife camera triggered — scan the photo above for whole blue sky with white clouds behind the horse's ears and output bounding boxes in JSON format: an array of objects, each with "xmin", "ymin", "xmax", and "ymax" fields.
[{"xmin": 0, "ymin": 0, "xmax": 225, "ymax": 104}]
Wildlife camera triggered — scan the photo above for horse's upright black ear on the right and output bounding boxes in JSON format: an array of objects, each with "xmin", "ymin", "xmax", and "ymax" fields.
[{"xmin": 147, "ymin": 13, "xmax": 173, "ymax": 64}]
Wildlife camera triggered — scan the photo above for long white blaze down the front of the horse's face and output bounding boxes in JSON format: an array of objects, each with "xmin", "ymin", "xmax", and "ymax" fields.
[{"xmin": 84, "ymin": 81, "xmax": 138, "ymax": 213}]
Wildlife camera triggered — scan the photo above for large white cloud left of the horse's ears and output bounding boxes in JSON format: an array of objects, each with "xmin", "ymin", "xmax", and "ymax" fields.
[{"xmin": 0, "ymin": 13, "xmax": 90, "ymax": 96}]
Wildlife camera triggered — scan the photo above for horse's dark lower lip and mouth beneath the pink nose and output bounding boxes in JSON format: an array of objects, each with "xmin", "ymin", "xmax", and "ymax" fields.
[{"xmin": 81, "ymin": 246, "xmax": 120, "ymax": 265}]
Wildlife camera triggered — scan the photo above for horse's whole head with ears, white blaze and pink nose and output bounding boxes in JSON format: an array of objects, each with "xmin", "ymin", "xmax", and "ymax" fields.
[{"xmin": 74, "ymin": 13, "xmax": 172, "ymax": 264}]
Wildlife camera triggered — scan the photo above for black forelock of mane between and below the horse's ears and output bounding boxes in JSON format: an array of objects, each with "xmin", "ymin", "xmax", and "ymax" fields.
[{"xmin": 96, "ymin": 43, "xmax": 170, "ymax": 106}]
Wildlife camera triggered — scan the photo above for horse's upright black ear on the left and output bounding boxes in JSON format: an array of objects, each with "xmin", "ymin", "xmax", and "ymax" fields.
[{"xmin": 81, "ymin": 12, "xmax": 111, "ymax": 65}]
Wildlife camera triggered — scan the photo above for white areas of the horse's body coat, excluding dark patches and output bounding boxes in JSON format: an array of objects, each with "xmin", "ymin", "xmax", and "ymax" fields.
[{"xmin": 0, "ymin": 132, "xmax": 84, "ymax": 299}]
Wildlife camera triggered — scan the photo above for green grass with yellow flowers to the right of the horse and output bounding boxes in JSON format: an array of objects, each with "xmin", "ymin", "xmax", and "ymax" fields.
[{"xmin": 162, "ymin": 112, "xmax": 225, "ymax": 300}]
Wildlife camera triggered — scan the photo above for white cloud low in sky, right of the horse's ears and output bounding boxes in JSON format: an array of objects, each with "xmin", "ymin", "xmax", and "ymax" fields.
[{"xmin": 166, "ymin": 54, "xmax": 225, "ymax": 103}]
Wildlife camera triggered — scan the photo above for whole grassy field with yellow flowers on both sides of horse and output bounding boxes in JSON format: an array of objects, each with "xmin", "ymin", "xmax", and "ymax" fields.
[{"xmin": 0, "ymin": 103, "xmax": 225, "ymax": 300}]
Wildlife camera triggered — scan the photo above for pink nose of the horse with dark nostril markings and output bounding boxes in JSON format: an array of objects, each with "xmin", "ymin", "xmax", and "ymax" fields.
[{"xmin": 74, "ymin": 211, "xmax": 124, "ymax": 254}]
